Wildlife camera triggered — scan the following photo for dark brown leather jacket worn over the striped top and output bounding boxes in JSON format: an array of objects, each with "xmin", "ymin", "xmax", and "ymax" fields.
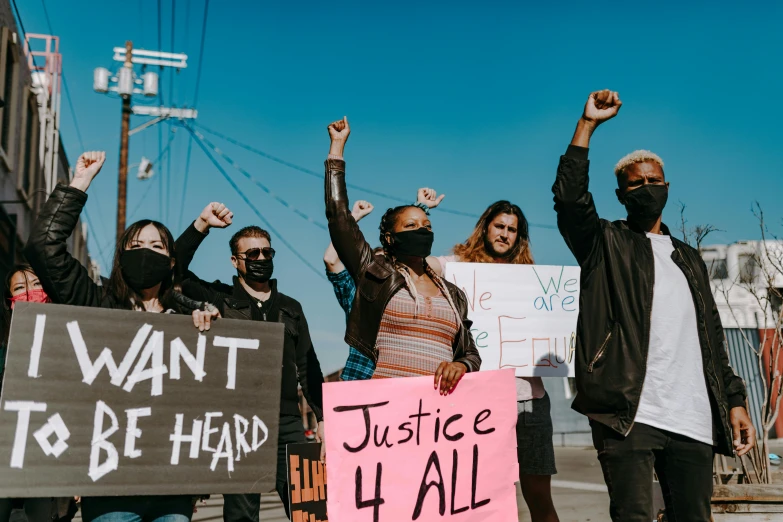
[{"xmin": 326, "ymin": 159, "xmax": 481, "ymax": 372}]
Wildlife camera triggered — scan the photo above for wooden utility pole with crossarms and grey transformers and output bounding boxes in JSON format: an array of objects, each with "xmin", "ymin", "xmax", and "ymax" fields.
[{"xmin": 93, "ymin": 41, "xmax": 198, "ymax": 240}]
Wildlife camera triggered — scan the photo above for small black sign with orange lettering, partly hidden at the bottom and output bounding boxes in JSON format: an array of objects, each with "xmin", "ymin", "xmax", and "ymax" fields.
[{"xmin": 286, "ymin": 442, "xmax": 328, "ymax": 522}]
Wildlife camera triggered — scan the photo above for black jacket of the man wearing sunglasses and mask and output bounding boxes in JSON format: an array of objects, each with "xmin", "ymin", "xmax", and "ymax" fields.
[{"xmin": 176, "ymin": 224, "xmax": 324, "ymax": 422}]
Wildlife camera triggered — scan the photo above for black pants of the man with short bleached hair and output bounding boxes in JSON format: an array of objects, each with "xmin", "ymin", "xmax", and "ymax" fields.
[{"xmin": 590, "ymin": 421, "xmax": 713, "ymax": 522}]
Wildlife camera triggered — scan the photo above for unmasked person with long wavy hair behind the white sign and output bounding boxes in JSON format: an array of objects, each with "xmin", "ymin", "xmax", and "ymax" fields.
[{"xmin": 428, "ymin": 199, "xmax": 559, "ymax": 522}]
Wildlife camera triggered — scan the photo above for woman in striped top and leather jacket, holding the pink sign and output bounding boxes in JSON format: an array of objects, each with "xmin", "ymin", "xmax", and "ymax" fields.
[{"xmin": 326, "ymin": 118, "xmax": 481, "ymax": 395}]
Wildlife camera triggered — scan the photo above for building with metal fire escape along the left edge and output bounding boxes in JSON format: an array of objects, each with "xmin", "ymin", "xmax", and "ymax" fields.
[{"xmin": 0, "ymin": 0, "xmax": 97, "ymax": 278}]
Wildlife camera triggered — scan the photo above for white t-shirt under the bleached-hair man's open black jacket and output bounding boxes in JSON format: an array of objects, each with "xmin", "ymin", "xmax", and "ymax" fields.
[{"xmin": 634, "ymin": 233, "xmax": 713, "ymax": 445}]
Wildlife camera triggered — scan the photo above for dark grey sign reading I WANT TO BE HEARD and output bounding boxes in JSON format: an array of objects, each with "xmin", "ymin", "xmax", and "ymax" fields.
[{"xmin": 0, "ymin": 303, "xmax": 283, "ymax": 497}]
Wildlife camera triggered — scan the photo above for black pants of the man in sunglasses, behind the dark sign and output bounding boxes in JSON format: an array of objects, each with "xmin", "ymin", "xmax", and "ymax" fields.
[{"xmin": 223, "ymin": 415, "xmax": 305, "ymax": 522}]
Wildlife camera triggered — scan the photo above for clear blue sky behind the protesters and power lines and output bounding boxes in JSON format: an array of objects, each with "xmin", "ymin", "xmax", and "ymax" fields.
[{"xmin": 17, "ymin": 0, "xmax": 783, "ymax": 371}]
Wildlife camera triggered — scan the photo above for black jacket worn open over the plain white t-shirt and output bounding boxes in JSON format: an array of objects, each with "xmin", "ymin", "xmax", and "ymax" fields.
[{"xmin": 552, "ymin": 146, "xmax": 745, "ymax": 455}]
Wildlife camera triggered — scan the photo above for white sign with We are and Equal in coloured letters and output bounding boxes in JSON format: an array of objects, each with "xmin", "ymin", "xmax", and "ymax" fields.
[{"xmin": 446, "ymin": 263, "xmax": 580, "ymax": 377}]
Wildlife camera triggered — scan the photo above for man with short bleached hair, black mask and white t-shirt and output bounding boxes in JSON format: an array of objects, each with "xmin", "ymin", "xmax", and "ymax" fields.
[{"xmin": 552, "ymin": 90, "xmax": 756, "ymax": 522}]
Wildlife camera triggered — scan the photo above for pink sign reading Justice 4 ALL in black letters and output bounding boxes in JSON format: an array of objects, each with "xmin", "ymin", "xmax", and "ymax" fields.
[{"xmin": 324, "ymin": 370, "xmax": 519, "ymax": 522}]
